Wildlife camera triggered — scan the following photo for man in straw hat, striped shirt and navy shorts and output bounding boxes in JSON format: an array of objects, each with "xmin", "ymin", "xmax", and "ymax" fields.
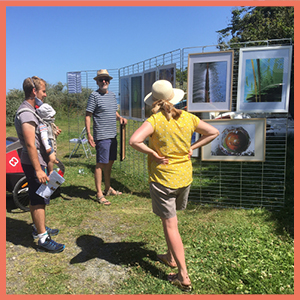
[{"xmin": 85, "ymin": 69, "xmax": 127, "ymax": 205}]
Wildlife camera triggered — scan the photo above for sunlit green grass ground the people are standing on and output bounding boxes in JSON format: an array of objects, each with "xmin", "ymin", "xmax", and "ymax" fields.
[{"xmin": 6, "ymin": 119, "xmax": 294, "ymax": 294}]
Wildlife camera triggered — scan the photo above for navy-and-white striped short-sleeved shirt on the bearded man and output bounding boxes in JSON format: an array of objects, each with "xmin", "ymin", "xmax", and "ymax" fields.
[{"xmin": 86, "ymin": 91, "xmax": 118, "ymax": 141}]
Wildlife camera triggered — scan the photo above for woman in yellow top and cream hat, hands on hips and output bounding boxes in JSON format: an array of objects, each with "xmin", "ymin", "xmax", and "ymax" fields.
[{"xmin": 129, "ymin": 80, "xmax": 219, "ymax": 291}]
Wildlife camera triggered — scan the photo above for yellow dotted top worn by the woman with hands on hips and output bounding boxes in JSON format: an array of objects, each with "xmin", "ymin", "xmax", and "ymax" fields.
[{"xmin": 147, "ymin": 111, "xmax": 200, "ymax": 189}]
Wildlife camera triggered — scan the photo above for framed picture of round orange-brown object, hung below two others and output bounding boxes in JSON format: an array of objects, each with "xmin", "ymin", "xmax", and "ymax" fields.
[{"xmin": 201, "ymin": 118, "xmax": 266, "ymax": 162}]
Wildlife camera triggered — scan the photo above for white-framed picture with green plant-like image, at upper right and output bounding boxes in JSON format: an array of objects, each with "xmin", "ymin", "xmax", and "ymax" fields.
[{"xmin": 237, "ymin": 46, "xmax": 292, "ymax": 112}]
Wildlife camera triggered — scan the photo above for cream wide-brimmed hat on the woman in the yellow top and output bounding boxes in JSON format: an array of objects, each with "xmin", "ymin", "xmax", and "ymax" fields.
[{"xmin": 144, "ymin": 80, "xmax": 184, "ymax": 106}]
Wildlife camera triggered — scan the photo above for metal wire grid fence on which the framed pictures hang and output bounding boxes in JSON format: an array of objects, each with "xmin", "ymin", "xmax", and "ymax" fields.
[{"xmin": 67, "ymin": 39, "xmax": 293, "ymax": 209}]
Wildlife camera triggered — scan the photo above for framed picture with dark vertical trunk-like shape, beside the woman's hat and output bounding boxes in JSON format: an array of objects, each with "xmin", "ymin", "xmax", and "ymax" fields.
[{"xmin": 187, "ymin": 50, "xmax": 234, "ymax": 112}]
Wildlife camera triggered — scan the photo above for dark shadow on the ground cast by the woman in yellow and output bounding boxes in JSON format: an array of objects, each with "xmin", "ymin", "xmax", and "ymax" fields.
[{"xmin": 70, "ymin": 235, "xmax": 161, "ymax": 276}]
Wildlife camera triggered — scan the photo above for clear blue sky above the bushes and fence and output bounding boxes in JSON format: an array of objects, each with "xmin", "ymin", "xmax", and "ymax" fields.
[{"xmin": 6, "ymin": 6, "xmax": 233, "ymax": 92}]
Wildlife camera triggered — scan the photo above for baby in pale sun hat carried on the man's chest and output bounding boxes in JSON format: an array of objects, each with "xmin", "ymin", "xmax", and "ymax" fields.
[{"xmin": 36, "ymin": 103, "xmax": 57, "ymax": 174}]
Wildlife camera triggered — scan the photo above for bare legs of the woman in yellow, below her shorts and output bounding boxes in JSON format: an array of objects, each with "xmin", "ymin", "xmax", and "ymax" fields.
[{"xmin": 161, "ymin": 216, "xmax": 191, "ymax": 285}]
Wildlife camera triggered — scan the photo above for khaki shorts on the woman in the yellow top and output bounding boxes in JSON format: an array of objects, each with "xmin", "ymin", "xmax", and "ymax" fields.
[{"xmin": 149, "ymin": 182, "xmax": 191, "ymax": 219}]
